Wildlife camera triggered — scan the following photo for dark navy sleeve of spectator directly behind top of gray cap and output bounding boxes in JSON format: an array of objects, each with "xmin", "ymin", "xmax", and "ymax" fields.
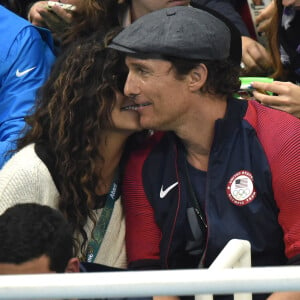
[{"xmin": 191, "ymin": 0, "xmax": 249, "ymax": 36}]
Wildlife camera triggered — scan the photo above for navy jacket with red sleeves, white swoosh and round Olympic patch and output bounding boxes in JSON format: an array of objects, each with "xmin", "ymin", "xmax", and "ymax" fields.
[{"xmin": 122, "ymin": 99, "xmax": 300, "ymax": 269}]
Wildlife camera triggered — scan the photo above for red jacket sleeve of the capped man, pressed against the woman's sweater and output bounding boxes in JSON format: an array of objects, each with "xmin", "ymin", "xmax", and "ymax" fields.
[{"xmin": 122, "ymin": 136, "xmax": 161, "ymax": 270}]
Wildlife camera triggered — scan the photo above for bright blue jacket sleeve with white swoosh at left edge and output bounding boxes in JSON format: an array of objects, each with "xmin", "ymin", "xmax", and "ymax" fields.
[{"xmin": 0, "ymin": 26, "xmax": 55, "ymax": 168}]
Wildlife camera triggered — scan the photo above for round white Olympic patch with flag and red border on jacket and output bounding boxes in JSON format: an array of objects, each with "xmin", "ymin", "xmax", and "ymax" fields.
[{"xmin": 226, "ymin": 170, "xmax": 256, "ymax": 206}]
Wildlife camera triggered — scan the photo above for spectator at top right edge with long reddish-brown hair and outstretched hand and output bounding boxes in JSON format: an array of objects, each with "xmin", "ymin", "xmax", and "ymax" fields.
[{"xmin": 252, "ymin": 0, "xmax": 300, "ymax": 118}]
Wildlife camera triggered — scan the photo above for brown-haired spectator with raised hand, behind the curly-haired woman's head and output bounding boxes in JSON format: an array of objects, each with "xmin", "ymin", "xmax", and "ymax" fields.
[{"xmin": 28, "ymin": 0, "xmax": 119, "ymax": 48}]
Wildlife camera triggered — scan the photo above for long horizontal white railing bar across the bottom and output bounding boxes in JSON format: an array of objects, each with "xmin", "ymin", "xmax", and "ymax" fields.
[{"xmin": 0, "ymin": 266, "xmax": 300, "ymax": 300}]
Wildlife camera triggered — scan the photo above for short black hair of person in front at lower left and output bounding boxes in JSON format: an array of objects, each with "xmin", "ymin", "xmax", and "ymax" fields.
[{"xmin": 0, "ymin": 203, "xmax": 73, "ymax": 273}]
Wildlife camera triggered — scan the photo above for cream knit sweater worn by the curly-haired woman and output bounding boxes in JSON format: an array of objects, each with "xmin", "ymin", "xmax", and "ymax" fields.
[{"xmin": 0, "ymin": 144, "xmax": 126, "ymax": 268}]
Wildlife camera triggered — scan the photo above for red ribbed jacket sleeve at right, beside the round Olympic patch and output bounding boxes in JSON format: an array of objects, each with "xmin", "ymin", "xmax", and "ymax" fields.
[{"xmin": 247, "ymin": 101, "xmax": 300, "ymax": 264}]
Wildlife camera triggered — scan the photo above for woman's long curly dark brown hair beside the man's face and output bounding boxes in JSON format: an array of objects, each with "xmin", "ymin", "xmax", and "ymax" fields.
[{"xmin": 18, "ymin": 30, "xmax": 130, "ymax": 254}]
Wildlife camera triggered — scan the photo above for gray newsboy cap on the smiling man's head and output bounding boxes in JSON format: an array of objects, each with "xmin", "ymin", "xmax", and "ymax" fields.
[{"xmin": 109, "ymin": 6, "xmax": 231, "ymax": 60}]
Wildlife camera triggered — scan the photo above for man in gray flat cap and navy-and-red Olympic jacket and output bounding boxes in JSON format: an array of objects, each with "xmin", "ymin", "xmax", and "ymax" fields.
[{"xmin": 110, "ymin": 7, "xmax": 300, "ymax": 299}]
